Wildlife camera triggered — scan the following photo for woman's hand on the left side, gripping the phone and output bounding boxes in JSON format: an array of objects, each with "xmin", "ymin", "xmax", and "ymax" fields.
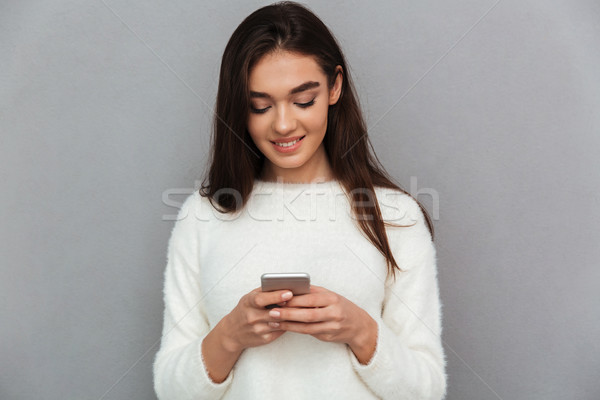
[{"xmin": 222, "ymin": 287, "xmax": 293, "ymax": 353}]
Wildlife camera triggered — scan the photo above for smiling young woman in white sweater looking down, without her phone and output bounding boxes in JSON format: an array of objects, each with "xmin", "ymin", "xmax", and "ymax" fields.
[{"xmin": 154, "ymin": 2, "xmax": 446, "ymax": 400}]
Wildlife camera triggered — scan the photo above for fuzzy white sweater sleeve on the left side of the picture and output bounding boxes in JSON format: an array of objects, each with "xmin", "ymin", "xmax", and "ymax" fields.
[{"xmin": 153, "ymin": 193, "xmax": 233, "ymax": 400}]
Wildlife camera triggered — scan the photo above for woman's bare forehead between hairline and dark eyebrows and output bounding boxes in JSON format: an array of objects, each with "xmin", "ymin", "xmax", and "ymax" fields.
[{"xmin": 248, "ymin": 51, "xmax": 327, "ymax": 95}]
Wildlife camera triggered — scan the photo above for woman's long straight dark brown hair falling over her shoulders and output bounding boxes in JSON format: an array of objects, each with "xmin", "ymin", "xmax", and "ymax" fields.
[{"xmin": 200, "ymin": 1, "xmax": 433, "ymax": 276}]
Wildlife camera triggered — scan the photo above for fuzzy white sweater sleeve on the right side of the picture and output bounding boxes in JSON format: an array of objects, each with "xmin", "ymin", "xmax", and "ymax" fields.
[{"xmin": 349, "ymin": 196, "xmax": 447, "ymax": 400}]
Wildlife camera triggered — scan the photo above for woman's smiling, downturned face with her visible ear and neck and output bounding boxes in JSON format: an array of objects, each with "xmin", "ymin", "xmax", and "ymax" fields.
[{"xmin": 247, "ymin": 51, "xmax": 342, "ymax": 182}]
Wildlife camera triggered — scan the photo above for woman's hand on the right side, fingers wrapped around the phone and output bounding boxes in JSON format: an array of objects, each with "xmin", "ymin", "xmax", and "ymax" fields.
[{"xmin": 269, "ymin": 285, "xmax": 377, "ymax": 364}]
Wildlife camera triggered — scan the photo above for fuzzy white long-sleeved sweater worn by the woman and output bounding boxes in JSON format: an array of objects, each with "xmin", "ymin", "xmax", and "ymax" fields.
[{"xmin": 154, "ymin": 181, "xmax": 446, "ymax": 400}]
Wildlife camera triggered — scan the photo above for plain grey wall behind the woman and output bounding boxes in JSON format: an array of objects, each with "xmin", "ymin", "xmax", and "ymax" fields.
[{"xmin": 0, "ymin": 0, "xmax": 600, "ymax": 400}]
